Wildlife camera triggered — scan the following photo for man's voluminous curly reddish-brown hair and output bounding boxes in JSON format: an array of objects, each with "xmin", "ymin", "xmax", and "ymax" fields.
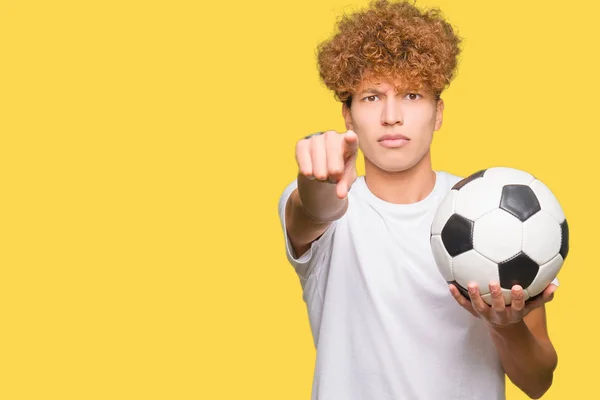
[{"xmin": 317, "ymin": 0, "xmax": 461, "ymax": 106}]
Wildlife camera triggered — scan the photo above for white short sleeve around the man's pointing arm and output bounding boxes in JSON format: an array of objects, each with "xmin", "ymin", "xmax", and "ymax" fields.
[{"xmin": 279, "ymin": 180, "xmax": 337, "ymax": 279}]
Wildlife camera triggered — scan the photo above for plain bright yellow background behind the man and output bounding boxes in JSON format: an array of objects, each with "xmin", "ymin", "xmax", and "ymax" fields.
[{"xmin": 0, "ymin": 0, "xmax": 600, "ymax": 400}]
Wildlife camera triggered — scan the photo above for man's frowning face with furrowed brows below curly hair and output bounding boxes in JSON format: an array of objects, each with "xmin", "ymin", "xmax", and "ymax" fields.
[{"xmin": 343, "ymin": 76, "xmax": 444, "ymax": 172}]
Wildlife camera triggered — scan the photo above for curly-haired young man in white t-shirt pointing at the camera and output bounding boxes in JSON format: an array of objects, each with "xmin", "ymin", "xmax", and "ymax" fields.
[{"xmin": 279, "ymin": 0, "xmax": 557, "ymax": 400}]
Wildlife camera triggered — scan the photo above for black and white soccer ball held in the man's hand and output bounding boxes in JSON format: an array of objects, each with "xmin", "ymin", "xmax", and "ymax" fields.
[{"xmin": 430, "ymin": 167, "xmax": 569, "ymax": 305}]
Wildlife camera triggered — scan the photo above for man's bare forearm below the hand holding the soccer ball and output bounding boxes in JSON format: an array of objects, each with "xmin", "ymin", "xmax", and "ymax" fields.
[{"xmin": 490, "ymin": 321, "xmax": 558, "ymax": 399}]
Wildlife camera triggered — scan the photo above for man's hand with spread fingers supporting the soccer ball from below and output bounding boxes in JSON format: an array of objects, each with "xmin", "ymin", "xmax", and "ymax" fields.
[{"xmin": 449, "ymin": 282, "xmax": 556, "ymax": 327}]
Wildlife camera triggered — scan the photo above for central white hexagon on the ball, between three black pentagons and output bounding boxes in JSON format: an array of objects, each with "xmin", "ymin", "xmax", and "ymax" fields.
[{"xmin": 473, "ymin": 209, "xmax": 523, "ymax": 263}]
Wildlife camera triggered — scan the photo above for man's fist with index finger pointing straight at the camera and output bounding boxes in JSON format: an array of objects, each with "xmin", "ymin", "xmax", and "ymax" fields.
[{"xmin": 296, "ymin": 131, "xmax": 358, "ymax": 199}]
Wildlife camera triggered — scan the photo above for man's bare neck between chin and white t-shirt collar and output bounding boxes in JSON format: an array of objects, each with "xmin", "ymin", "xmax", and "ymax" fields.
[{"xmin": 365, "ymin": 153, "xmax": 436, "ymax": 204}]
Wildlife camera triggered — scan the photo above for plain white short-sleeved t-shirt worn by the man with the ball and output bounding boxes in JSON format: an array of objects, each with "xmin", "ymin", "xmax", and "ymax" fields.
[{"xmin": 279, "ymin": 171, "xmax": 505, "ymax": 400}]
